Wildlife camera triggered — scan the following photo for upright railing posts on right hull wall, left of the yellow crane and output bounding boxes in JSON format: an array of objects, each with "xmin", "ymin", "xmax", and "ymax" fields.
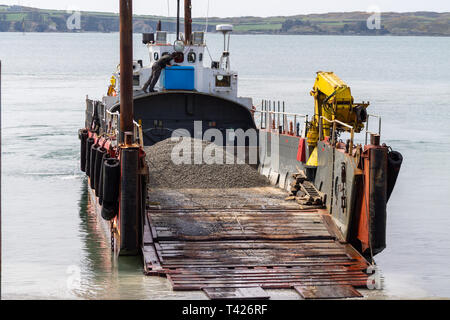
[{"xmin": 255, "ymin": 100, "xmax": 308, "ymax": 137}]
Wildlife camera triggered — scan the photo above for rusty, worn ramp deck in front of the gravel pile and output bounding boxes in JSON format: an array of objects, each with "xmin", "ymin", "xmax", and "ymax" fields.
[{"xmin": 143, "ymin": 187, "xmax": 368, "ymax": 299}]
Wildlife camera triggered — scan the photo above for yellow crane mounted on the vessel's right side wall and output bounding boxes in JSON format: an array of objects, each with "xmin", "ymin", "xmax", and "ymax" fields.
[{"xmin": 308, "ymin": 71, "xmax": 369, "ymax": 150}]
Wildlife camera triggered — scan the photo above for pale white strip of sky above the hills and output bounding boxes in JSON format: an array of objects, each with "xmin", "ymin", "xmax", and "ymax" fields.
[{"xmin": 0, "ymin": 0, "xmax": 450, "ymax": 17}]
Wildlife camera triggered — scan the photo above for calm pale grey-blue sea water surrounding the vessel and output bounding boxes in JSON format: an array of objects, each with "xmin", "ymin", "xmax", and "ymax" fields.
[{"xmin": 0, "ymin": 33, "xmax": 450, "ymax": 299}]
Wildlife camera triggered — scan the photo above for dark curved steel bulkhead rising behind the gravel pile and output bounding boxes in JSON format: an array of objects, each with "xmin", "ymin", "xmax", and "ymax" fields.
[{"xmin": 110, "ymin": 91, "xmax": 256, "ymax": 146}]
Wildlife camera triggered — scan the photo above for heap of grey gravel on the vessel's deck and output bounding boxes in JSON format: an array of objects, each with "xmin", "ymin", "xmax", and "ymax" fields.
[{"xmin": 145, "ymin": 138, "xmax": 269, "ymax": 189}]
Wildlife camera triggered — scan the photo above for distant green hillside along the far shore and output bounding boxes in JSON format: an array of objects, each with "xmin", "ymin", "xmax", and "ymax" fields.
[{"xmin": 0, "ymin": 5, "xmax": 450, "ymax": 36}]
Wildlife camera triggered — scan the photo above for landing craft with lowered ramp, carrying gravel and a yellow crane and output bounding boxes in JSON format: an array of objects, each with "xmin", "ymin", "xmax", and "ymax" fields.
[{"xmin": 79, "ymin": 0, "xmax": 402, "ymax": 299}]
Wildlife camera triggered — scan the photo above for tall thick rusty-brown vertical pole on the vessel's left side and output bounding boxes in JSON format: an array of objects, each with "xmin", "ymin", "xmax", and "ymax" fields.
[{"xmin": 120, "ymin": 0, "xmax": 134, "ymax": 143}]
